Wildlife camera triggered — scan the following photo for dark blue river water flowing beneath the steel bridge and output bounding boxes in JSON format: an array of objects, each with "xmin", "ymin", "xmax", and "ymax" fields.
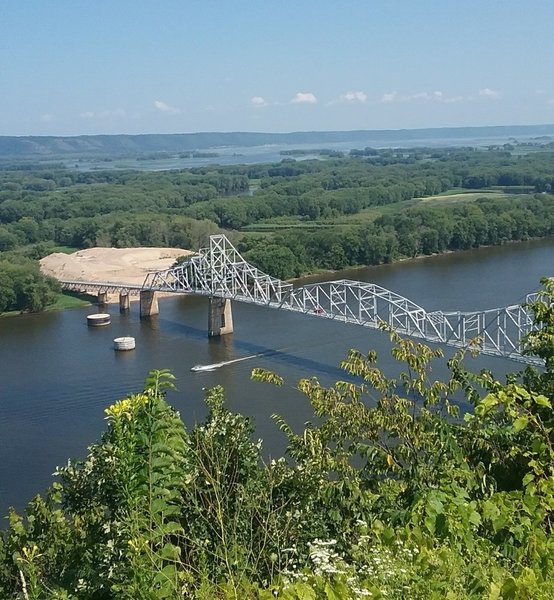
[{"xmin": 0, "ymin": 240, "xmax": 554, "ymax": 515}]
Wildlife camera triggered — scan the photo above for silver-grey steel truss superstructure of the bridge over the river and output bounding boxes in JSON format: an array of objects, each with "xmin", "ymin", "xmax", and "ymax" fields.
[{"xmin": 138, "ymin": 235, "xmax": 542, "ymax": 364}]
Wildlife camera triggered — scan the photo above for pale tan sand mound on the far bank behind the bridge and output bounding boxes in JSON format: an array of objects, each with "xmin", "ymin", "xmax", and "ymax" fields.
[{"xmin": 40, "ymin": 248, "xmax": 192, "ymax": 300}]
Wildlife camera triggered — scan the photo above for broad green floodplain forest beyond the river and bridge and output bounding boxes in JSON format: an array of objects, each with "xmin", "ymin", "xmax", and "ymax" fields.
[{"xmin": 0, "ymin": 144, "xmax": 554, "ymax": 311}]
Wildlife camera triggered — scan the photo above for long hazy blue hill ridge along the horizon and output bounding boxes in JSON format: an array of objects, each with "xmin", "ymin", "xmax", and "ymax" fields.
[{"xmin": 0, "ymin": 125, "xmax": 554, "ymax": 158}]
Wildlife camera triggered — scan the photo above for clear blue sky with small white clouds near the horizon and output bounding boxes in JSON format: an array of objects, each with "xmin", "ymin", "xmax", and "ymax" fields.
[{"xmin": 0, "ymin": 0, "xmax": 554, "ymax": 135}]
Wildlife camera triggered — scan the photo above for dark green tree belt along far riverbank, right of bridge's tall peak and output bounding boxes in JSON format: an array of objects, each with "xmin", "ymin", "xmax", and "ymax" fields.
[{"xmin": 239, "ymin": 195, "xmax": 554, "ymax": 279}]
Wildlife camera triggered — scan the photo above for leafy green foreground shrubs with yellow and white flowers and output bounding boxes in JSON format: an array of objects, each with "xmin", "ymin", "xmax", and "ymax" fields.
[{"xmin": 0, "ymin": 279, "xmax": 554, "ymax": 600}]
